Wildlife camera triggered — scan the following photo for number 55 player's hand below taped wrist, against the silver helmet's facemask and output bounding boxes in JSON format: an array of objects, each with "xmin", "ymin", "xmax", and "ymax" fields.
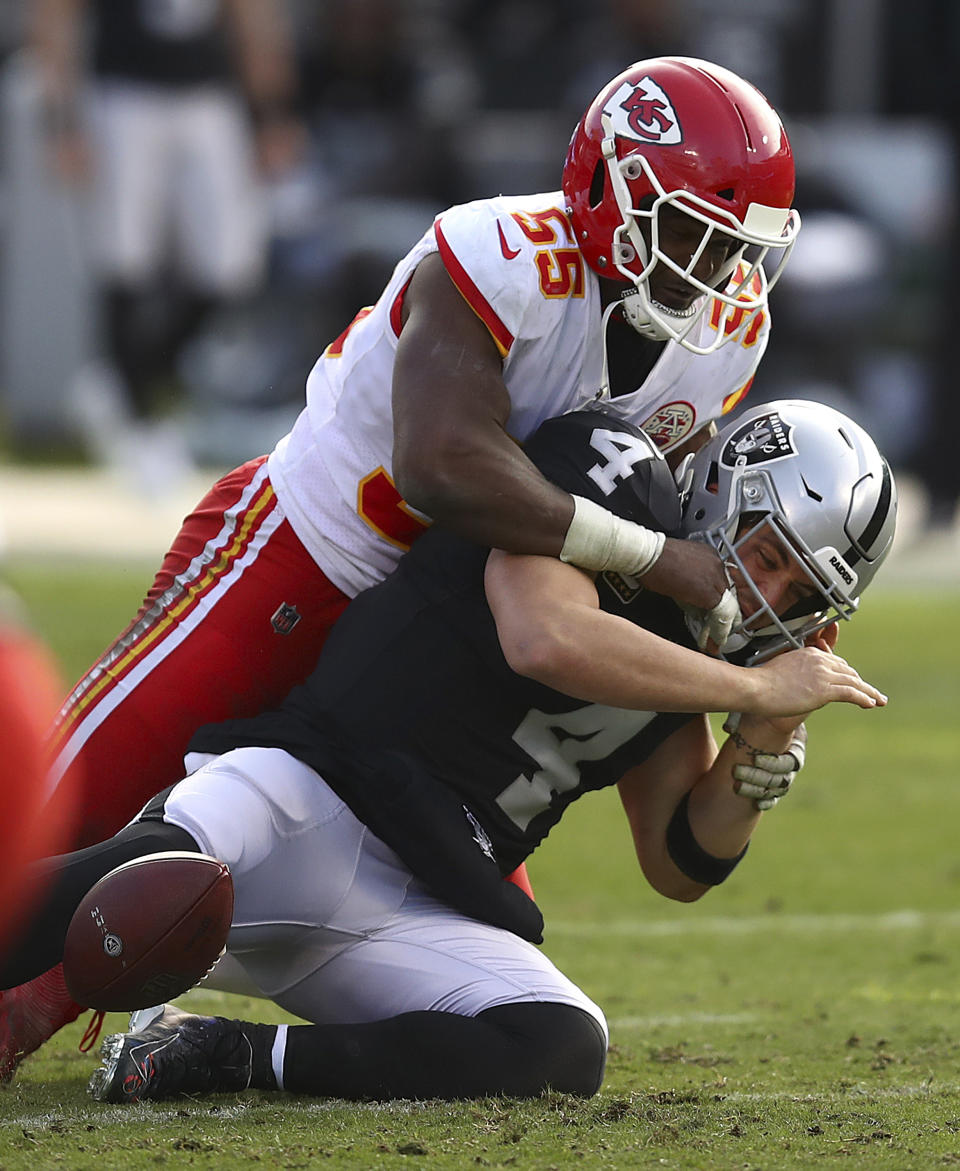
[{"xmin": 642, "ymin": 537, "xmax": 740, "ymax": 650}]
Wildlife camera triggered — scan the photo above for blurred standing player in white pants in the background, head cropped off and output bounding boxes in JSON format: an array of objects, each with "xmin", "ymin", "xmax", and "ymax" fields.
[{"xmin": 33, "ymin": 0, "xmax": 306, "ymax": 484}]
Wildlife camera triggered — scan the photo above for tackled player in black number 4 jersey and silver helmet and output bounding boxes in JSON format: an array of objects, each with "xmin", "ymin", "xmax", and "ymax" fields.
[{"xmin": 2, "ymin": 402, "xmax": 896, "ymax": 1102}]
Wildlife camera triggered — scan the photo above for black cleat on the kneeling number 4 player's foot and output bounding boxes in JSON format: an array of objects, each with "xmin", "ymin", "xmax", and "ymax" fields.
[{"xmin": 88, "ymin": 1005, "xmax": 253, "ymax": 1102}]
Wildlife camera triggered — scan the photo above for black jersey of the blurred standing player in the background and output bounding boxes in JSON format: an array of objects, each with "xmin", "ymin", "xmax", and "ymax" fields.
[{"xmin": 91, "ymin": 0, "xmax": 231, "ymax": 87}]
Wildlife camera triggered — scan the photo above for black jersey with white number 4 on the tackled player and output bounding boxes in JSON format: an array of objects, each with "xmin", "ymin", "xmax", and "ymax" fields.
[{"xmin": 191, "ymin": 411, "xmax": 693, "ymax": 934}]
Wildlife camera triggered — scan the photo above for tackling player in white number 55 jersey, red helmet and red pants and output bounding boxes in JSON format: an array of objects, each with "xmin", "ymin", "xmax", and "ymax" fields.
[{"xmin": 0, "ymin": 57, "xmax": 798, "ymax": 1075}]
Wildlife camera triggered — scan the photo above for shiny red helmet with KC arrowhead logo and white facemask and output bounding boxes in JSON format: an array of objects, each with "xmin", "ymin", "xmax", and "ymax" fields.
[{"xmin": 563, "ymin": 57, "xmax": 800, "ymax": 354}]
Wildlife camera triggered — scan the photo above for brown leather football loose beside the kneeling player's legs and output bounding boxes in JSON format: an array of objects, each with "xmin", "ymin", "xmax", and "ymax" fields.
[{"xmin": 63, "ymin": 850, "xmax": 233, "ymax": 1012}]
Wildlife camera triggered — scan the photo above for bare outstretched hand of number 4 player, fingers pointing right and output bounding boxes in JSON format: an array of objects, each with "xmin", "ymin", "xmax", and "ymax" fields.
[{"xmin": 743, "ymin": 646, "xmax": 886, "ymax": 719}]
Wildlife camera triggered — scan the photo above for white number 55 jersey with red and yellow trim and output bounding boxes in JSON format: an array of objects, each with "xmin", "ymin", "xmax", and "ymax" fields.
[{"xmin": 268, "ymin": 191, "xmax": 769, "ymax": 596}]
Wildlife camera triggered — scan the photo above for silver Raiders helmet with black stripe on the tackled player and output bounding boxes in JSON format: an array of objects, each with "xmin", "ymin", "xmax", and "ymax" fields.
[{"xmin": 681, "ymin": 400, "xmax": 897, "ymax": 660}]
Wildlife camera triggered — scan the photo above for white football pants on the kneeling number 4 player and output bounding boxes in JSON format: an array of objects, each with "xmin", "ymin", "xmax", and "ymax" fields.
[{"xmin": 164, "ymin": 748, "xmax": 606, "ymax": 1032}]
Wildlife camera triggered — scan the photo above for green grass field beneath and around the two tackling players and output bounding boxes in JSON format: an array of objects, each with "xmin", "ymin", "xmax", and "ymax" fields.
[{"xmin": 0, "ymin": 563, "xmax": 960, "ymax": 1171}]
